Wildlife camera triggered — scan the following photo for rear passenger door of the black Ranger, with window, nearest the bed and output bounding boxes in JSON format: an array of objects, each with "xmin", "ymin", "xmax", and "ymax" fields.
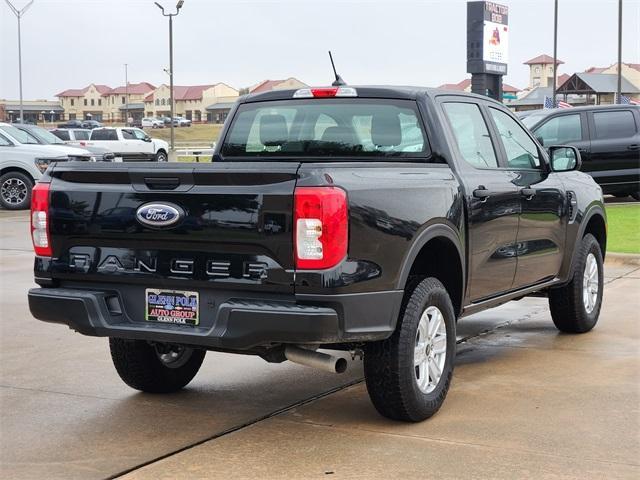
[{"xmin": 442, "ymin": 97, "xmax": 520, "ymax": 301}]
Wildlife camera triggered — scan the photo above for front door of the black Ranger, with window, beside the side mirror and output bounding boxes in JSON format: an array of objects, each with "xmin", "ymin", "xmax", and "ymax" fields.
[{"xmin": 488, "ymin": 107, "xmax": 566, "ymax": 289}]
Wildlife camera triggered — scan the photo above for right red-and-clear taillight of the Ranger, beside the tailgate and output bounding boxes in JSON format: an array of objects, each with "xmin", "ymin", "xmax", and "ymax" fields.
[{"xmin": 293, "ymin": 187, "xmax": 349, "ymax": 270}]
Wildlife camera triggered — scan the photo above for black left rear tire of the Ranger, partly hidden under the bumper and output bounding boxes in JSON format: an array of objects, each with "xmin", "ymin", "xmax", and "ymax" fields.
[{"xmin": 109, "ymin": 338, "xmax": 206, "ymax": 393}]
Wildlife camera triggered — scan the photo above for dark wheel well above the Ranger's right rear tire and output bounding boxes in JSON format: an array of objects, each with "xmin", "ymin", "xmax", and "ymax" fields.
[{"xmin": 409, "ymin": 237, "xmax": 463, "ymax": 315}]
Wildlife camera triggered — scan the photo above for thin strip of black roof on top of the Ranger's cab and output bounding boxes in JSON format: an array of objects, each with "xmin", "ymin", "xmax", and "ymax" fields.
[{"xmin": 239, "ymin": 85, "xmax": 502, "ymax": 105}]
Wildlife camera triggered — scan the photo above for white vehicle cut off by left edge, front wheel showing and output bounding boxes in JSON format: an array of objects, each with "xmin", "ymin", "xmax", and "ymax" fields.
[{"xmin": 0, "ymin": 123, "xmax": 91, "ymax": 210}]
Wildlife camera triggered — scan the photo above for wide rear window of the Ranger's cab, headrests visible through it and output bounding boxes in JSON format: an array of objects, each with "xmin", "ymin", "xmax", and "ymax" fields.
[{"xmin": 220, "ymin": 98, "xmax": 430, "ymax": 159}]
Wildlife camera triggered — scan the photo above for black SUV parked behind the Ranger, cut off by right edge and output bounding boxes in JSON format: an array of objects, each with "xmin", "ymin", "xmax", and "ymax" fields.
[{"xmin": 522, "ymin": 105, "xmax": 640, "ymax": 200}]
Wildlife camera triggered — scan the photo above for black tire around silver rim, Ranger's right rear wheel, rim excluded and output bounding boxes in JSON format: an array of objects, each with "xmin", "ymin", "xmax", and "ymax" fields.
[{"xmin": 364, "ymin": 278, "xmax": 456, "ymax": 422}]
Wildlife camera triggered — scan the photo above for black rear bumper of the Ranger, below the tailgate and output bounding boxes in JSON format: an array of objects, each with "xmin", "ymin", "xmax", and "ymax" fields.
[{"xmin": 29, "ymin": 288, "xmax": 403, "ymax": 350}]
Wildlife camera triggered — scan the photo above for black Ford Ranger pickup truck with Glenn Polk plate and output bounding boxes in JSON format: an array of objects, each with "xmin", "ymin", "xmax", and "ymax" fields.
[{"xmin": 29, "ymin": 86, "xmax": 606, "ymax": 421}]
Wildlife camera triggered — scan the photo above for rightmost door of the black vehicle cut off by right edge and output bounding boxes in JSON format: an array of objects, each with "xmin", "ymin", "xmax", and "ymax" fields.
[{"xmin": 583, "ymin": 107, "xmax": 640, "ymax": 193}]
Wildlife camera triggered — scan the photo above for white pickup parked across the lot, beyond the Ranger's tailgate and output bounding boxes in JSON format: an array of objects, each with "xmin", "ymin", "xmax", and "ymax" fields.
[{"xmin": 87, "ymin": 127, "xmax": 169, "ymax": 162}]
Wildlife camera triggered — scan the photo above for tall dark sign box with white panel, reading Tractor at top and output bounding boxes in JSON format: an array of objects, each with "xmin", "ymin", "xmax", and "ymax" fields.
[{"xmin": 467, "ymin": 2, "xmax": 509, "ymax": 75}]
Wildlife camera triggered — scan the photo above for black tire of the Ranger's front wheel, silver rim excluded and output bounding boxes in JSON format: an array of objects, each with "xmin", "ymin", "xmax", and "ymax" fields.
[{"xmin": 549, "ymin": 233, "xmax": 604, "ymax": 333}]
